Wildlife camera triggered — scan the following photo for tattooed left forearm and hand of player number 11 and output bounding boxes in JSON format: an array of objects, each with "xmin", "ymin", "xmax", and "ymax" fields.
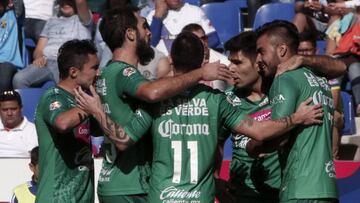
[{"xmin": 75, "ymin": 86, "xmax": 134, "ymax": 150}]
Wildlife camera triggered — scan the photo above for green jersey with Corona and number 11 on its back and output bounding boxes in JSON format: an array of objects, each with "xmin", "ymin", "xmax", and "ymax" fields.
[{"xmin": 125, "ymin": 85, "xmax": 243, "ymax": 203}]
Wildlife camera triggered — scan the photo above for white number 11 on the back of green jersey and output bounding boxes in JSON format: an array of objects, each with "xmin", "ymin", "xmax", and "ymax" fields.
[{"xmin": 171, "ymin": 141, "xmax": 198, "ymax": 184}]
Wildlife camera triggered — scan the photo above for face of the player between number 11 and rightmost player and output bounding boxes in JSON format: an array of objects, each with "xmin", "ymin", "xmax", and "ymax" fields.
[{"xmin": 229, "ymin": 51, "xmax": 260, "ymax": 89}]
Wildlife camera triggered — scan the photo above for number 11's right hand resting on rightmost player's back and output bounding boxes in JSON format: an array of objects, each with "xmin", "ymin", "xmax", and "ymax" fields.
[{"xmin": 292, "ymin": 97, "xmax": 324, "ymax": 125}]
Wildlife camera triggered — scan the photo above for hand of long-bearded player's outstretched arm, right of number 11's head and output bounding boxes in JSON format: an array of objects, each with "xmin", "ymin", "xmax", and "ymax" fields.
[{"xmin": 201, "ymin": 61, "xmax": 231, "ymax": 81}]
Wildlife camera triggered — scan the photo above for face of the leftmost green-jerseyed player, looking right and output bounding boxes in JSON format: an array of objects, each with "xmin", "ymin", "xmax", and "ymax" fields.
[{"xmin": 76, "ymin": 54, "xmax": 99, "ymax": 89}]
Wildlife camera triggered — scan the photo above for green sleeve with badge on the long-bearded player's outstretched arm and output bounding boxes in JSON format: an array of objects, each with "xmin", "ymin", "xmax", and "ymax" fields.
[{"xmin": 117, "ymin": 66, "xmax": 147, "ymax": 97}]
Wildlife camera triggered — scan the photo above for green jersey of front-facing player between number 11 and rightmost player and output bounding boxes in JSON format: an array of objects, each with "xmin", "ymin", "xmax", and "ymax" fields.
[{"xmin": 226, "ymin": 88, "xmax": 281, "ymax": 202}]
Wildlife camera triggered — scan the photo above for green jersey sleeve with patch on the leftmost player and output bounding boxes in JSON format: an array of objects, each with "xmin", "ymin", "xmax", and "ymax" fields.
[{"xmin": 43, "ymin": 95, "xmax": 68, "ymax": 125}]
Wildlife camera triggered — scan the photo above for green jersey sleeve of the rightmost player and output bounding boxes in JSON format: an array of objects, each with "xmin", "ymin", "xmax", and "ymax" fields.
[{"xmin": 269, "ymin": 73, "xmax": 300, "ymax": 119}]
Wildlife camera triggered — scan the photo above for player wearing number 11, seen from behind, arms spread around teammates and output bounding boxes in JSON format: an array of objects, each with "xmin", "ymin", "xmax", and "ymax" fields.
[{"xmin": 78, "ymin": 32, "xmax": 321, "ymax": 203}]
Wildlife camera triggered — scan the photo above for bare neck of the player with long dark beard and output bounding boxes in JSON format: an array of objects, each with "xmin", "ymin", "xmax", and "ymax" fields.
[{"xmin": 112, "ymin": 46, "xmax": 139, "ymax": 67}]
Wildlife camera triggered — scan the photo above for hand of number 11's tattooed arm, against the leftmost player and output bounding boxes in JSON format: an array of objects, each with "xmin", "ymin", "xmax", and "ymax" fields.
[{"xmin": 74, "ymin": 85, "xmax": 102, "ymax": 115}]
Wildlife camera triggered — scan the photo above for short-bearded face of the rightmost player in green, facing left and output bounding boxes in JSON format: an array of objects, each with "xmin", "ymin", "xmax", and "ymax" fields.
[{"xmin": 256, "ymin": 34, "xmax": 280, "ymax": 77}]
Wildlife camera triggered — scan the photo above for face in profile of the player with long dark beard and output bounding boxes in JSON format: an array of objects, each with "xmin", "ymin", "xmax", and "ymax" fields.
[{"xmin": 136, "ymin": 14, "xmax": 154, "ymax": 65}]
